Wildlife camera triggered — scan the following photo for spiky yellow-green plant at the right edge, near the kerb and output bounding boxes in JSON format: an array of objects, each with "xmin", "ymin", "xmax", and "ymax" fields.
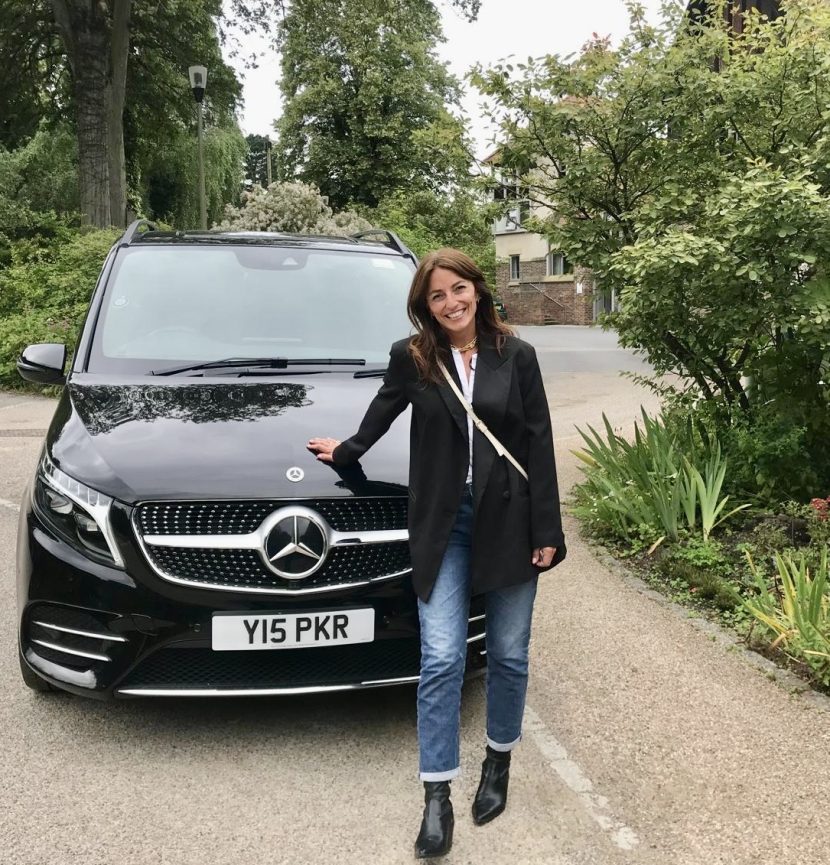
[{"xmin": 746, "ymin": 547, "xmax": 830, "ymax": 685}]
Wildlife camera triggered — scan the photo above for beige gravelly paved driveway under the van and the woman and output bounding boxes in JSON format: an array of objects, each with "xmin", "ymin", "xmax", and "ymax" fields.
[{"xmin": 0, "ymin": 327, "xmax": 830, "ymax": 865}]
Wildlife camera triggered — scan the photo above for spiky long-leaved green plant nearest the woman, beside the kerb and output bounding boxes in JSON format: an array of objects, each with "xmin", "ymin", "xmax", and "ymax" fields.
[{"xmin": 574, "ymin": 410, "xmax": 747, "ymax": 546}]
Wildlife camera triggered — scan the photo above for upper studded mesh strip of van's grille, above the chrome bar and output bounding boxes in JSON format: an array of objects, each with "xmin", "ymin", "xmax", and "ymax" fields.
[{"xmin": 137, "ymin": 496, "xmax": 408, "ymax": 535}]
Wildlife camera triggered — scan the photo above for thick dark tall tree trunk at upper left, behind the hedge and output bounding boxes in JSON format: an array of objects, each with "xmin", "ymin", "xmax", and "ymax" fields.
[{"xmin": 52, "ymin": 0, "xmax": 131, "ymax": 228}]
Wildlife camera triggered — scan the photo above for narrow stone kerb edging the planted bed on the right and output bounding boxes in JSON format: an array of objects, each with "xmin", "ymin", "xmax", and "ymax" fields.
[{"xmin": 581, "ymin": 536, "xmax": 830, "ymax": 714}]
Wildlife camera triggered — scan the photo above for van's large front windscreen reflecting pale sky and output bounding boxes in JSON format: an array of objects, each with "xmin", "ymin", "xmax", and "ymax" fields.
[{"xmin": 88, "ymin": 246, "xmax": 414, "ymax": 373}]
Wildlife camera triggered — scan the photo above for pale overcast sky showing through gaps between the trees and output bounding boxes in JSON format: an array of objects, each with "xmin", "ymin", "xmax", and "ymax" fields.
[{"xmin": 224, "ymin": 0, "xmax": 672, "ymax": 157}]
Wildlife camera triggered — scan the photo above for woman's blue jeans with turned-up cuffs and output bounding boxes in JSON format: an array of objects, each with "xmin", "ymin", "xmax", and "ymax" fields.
[{"xmin": 418, "ymin": 486, "xmax": 537, "ymax": 781}]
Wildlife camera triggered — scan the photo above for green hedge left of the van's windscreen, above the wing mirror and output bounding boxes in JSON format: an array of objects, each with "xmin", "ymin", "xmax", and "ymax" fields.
[{"xmin": 0, "ymin": 227, "xmax": 119, "ymax": 388}]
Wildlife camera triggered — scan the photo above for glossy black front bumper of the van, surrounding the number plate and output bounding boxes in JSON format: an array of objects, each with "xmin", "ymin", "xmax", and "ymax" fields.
[{"xmin": 17, "ymin": 507, "xmax": 486, "ymax": 700}]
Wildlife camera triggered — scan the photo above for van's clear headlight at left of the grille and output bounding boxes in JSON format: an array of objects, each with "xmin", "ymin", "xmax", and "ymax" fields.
[{"xmin": 34, "ymin": 454, "xmax": 124, "ymax": 568}]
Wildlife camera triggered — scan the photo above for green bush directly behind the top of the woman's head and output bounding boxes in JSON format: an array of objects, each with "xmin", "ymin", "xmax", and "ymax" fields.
[{"xmin": 365, "ymin": 191, "xmax": 496, "ymax": 286}]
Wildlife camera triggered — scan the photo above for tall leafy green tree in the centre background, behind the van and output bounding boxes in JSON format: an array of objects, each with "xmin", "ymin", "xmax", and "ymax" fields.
[{"xmin": 278, "ymin": 0, "xmax": 470, "ymax": 207}]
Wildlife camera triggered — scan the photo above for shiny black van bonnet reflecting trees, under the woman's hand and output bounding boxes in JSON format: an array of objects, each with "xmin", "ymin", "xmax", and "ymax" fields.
[{"xmin": 47, "ymin": 373, "xmax": 409, "ymax": 503}]
